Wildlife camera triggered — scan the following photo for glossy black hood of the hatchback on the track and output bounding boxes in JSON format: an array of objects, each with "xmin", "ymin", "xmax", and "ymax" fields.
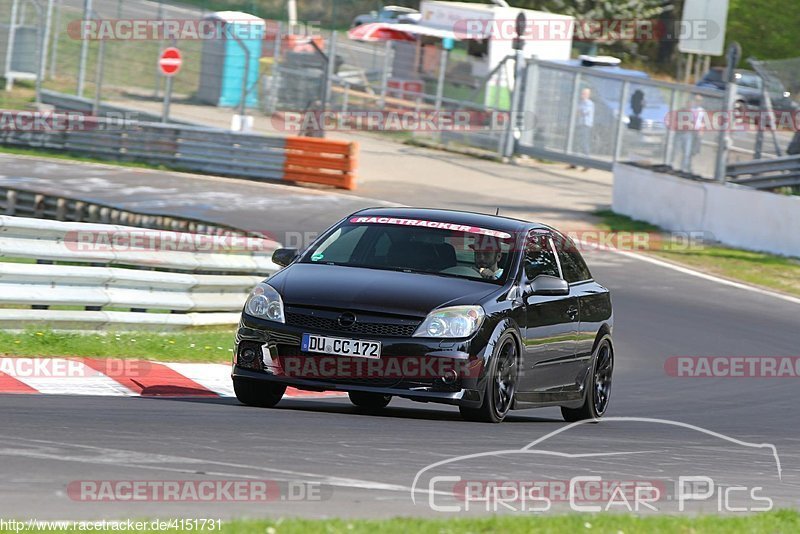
[{"xmin": 268, "ymin": 263, "xmax": 501, "ymax": 317}]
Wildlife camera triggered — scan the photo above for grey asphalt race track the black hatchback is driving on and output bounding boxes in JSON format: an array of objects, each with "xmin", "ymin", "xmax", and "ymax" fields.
[{"xmin": 0, "ymin": 160, "xmax": 800, "ymax": 519}]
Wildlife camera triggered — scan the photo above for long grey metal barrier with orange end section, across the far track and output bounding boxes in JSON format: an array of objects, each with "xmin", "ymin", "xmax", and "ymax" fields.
[{"xmin": 0, "ymin": 118, "xmax": 358, "ymax": 189}]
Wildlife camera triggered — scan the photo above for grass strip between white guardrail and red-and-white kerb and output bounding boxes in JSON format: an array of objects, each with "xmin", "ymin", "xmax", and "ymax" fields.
[{"xmin": 0, "ymin": 326, "xmax": 236, "ymax": 363}]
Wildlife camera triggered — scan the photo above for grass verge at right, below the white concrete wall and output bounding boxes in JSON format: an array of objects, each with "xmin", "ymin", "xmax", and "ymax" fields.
[{"xmin": 595, "ymin": 210, "xmax": 800, "ymax": 296}]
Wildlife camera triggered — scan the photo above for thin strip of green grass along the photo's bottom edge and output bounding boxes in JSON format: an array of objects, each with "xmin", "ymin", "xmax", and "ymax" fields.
[{"xmin": 0, "ymin": 510, "xmax": 800, "ymax": 534}]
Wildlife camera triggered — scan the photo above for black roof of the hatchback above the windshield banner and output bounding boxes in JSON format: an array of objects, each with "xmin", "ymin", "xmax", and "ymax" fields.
[{"xmin": 353, "ymin": 208, "xmax": 551, "ymax": 232}]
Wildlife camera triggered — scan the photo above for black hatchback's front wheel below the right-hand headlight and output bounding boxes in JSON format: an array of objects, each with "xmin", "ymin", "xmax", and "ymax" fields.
[{"xmin": 459, "ymin": 332, "xmax": 518, "ymax": 423}]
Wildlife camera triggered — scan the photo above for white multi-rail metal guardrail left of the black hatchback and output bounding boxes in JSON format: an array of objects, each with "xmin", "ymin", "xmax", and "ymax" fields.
[{"xmin": 0, "ymin": 216, "xmax": 280, "ymax": 329}]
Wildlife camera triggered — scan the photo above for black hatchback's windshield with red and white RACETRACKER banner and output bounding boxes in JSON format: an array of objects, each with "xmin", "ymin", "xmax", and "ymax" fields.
[{"xmin": 300, "ymin": 217, "xmax": 513, "ymax": 284}]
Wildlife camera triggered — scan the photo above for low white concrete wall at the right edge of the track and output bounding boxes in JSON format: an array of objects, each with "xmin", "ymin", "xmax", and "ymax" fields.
[{"xmin": 612, "ymin": 163, "xmax": 800, "ymax": 257}]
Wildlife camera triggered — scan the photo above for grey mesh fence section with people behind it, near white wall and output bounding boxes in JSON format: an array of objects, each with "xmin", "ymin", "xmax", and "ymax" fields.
[{"xmin": 520, "ymin": 61, "xmax": 752, "ymax": 179}]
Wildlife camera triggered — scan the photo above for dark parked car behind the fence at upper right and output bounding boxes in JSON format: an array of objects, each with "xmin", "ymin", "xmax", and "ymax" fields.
[{"xmin": 697, "ymin": 67, "xmax": 800, "ymax": 111}]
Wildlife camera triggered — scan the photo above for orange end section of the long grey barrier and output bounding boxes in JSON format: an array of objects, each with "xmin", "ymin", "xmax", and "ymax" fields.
[{"xmin": 283, "ymin": 137, "xmax": 358, "ymax": 189}]
